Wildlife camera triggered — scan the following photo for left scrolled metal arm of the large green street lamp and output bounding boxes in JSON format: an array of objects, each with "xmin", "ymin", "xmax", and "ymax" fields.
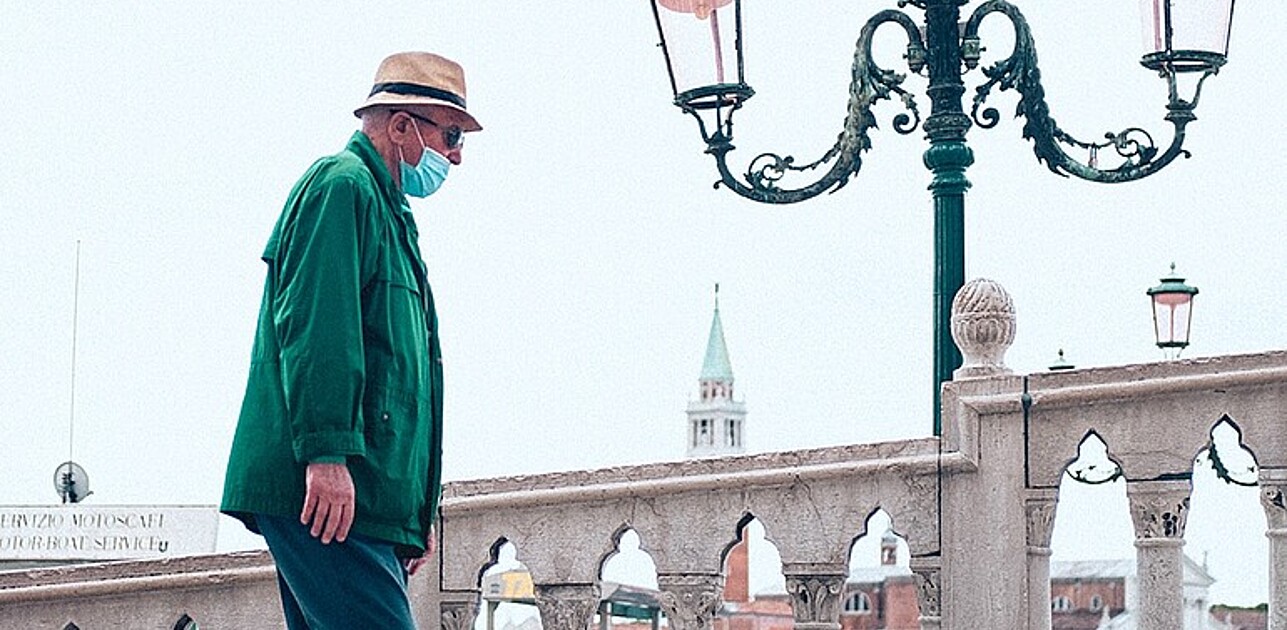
[{"xmin": 699, "ymin": 9, "xmax": 924, "ymax": 203}]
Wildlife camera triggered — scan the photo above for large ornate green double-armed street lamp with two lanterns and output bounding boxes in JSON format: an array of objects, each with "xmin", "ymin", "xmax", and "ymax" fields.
[{"xmin": 650, "ymin": 0, "xmax": 1233, "ymax": 435}]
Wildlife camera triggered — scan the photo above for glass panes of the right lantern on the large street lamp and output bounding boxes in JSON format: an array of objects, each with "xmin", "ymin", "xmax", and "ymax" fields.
[{"xmin": 1140, "ymin": 0, "xmax": 1233, "ymax": 55}]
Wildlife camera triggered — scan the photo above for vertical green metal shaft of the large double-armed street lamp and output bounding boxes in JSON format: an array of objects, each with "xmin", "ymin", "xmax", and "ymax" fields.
[{"xmin": 924, "ymin": 0, "xmax": 974, "ymax": 436}]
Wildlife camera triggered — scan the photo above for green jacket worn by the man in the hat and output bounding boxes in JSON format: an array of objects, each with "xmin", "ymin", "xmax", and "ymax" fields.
[{"xmin": 220, "ymin": 131, "xmax": 443, "ymax": 555}]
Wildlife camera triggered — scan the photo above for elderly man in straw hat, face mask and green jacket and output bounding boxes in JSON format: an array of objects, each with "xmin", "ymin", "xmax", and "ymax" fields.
[{"xmin": 220, "ymin": 53, "xmax": 483, "ymax": 630}]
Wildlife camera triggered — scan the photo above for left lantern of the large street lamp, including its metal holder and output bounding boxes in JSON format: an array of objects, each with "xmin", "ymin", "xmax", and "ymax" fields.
[{"xmin": 651, "ymin": 0, "xmax": 755, "ymax": 144}]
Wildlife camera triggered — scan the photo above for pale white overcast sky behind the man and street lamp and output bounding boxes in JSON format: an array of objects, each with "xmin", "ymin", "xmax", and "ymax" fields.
[{"xmin": 0, "ymin": 0, "xmax": 1287, "ymax": 602}]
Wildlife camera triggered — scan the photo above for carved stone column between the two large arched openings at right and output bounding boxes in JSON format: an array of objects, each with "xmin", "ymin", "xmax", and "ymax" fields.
[{"xmin": 1126, "ymin": 480, "xmax": 1192, "ymax": 630}]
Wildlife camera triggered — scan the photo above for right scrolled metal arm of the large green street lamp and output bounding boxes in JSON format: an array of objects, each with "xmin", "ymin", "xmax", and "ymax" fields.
[{"xmin": 963, "ymin": 0, "xmax": 1215, "ymax": 183}]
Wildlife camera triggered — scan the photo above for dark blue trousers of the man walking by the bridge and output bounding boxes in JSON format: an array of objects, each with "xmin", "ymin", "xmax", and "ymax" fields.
[{"xmin": 255, "ymin": 514, "xmax": 416, "ymax": 630}]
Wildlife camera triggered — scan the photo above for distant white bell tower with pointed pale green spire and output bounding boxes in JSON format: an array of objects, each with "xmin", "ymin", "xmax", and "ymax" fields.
[{"xmin": 687, "ymin": 284, "xmax": 746, "ymax": 458}]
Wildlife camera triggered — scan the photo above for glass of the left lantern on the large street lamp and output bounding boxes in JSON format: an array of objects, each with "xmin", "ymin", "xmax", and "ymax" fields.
[{"xmin": 655, "ymin": 0, "xmax": 741, "ymax": 95}]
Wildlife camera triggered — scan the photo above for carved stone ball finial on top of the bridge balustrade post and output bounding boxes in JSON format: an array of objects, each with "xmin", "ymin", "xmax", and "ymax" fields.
[{"xmin": 952, "ymin": 278, "xmax": 1015, "ymax": 379}]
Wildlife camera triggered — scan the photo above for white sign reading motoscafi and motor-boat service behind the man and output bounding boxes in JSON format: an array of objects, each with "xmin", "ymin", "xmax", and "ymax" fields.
[{"xmin": 0, "ymin": 504, "xmax": 219, "ymax": 561}]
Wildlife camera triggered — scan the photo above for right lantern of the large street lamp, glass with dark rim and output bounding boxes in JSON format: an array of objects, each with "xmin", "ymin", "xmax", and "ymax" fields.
[{"xmin": 1140, "ymin": 0, "xmax": 1234, "ymax": 72}]
